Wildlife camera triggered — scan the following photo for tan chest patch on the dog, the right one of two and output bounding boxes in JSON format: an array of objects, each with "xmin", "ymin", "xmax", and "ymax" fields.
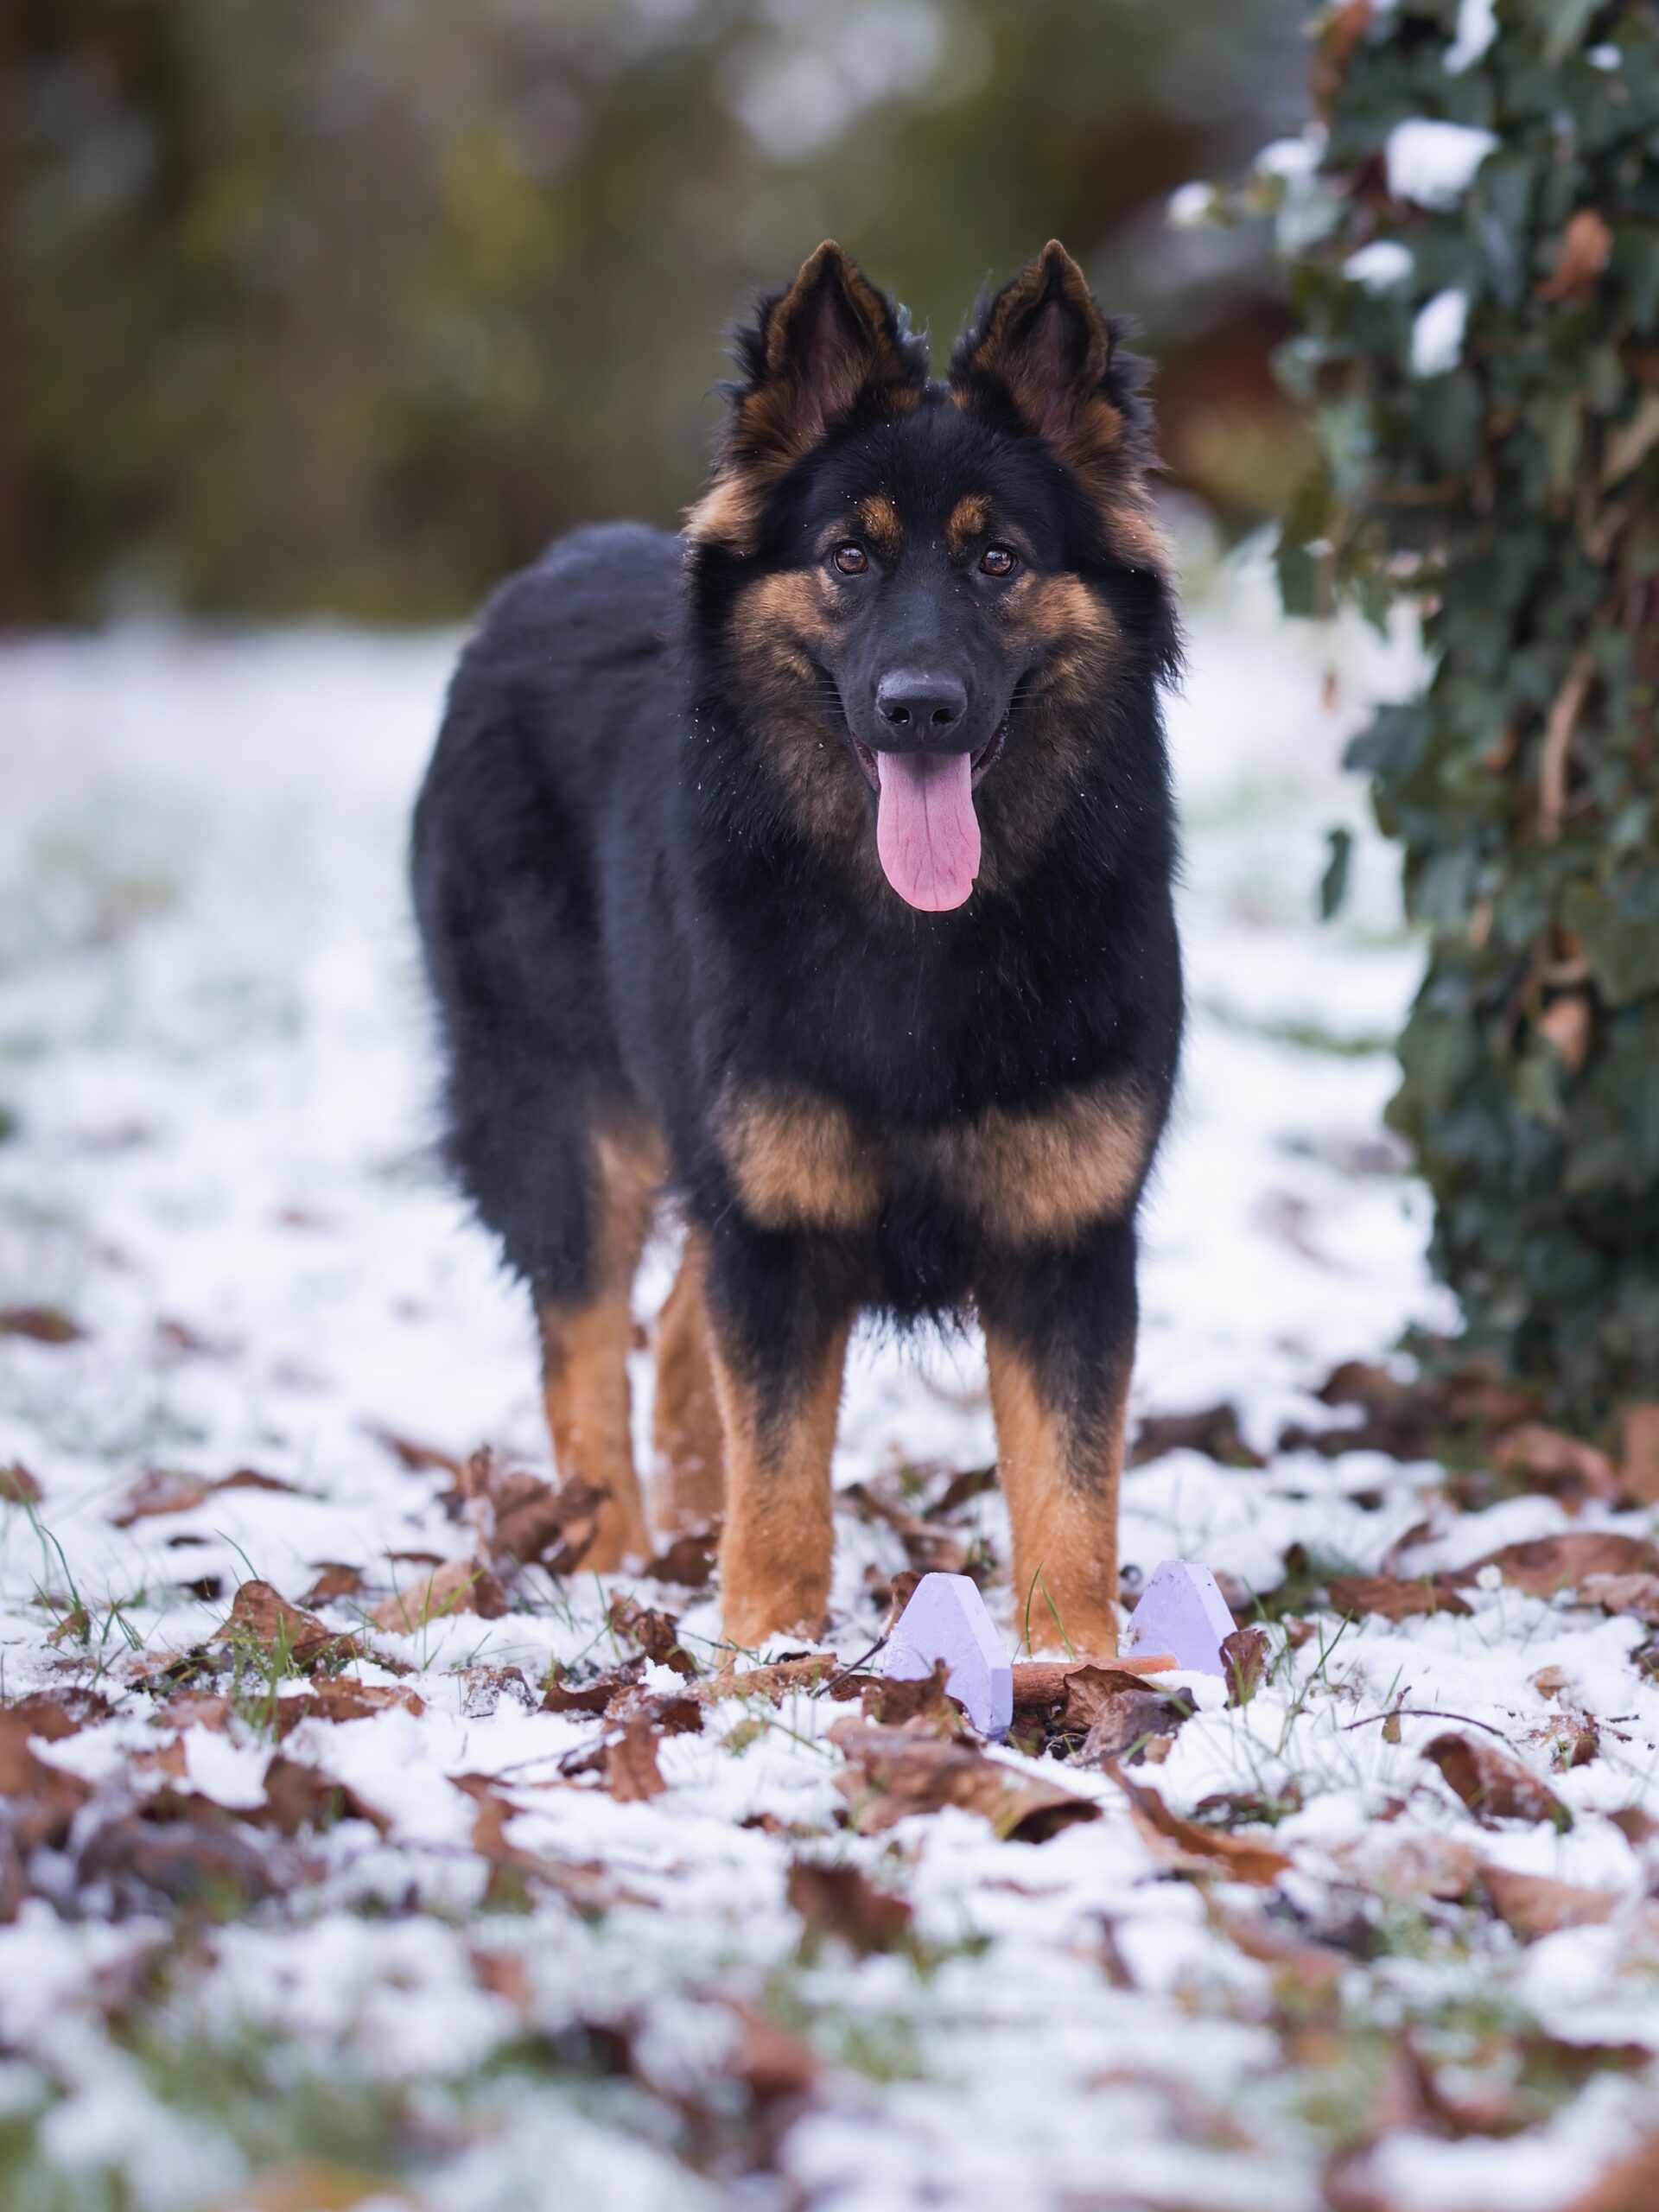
[{"xmin": 938, "ymin": 1084, "xmax": 1150, "ymax": 1249}]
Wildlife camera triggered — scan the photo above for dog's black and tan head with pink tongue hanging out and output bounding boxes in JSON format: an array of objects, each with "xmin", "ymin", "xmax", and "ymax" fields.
[{"xmin": 688, "ymin": 244, "xmax": 1177, "ymax": 912}]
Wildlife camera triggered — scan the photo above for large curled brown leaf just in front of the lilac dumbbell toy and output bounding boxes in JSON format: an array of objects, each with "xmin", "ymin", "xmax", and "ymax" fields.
[{"xmin": 830, "ymin": 1719, "xmax": 1099, "ymax": 1842}]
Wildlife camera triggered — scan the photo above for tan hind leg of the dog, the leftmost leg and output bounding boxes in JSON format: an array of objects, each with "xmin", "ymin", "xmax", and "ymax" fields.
[{"xmin": 536, "ymin": 1123, "xmax": 664, "ymax": 1575}]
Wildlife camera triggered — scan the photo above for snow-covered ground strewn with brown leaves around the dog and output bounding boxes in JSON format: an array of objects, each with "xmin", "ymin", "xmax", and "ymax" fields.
[{"xmin": 0, "ymin": 573, "xmax": 1659, "ymax": 2212}]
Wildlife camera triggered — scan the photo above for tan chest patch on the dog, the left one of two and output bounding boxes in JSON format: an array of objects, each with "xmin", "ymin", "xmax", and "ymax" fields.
[{"xmin": 716, "ymin": 1090, "xmax": 882, "ymax": 1232}]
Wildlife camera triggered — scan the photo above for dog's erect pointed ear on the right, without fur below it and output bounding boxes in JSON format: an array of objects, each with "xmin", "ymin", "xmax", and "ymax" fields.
[{"xmin": 951, "ymin": 238, "xmax": 1144, "ymax": 491}]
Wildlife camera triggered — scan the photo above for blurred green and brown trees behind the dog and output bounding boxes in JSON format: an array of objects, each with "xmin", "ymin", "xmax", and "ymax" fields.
[{"xmin": 0, "ymin": 0, "xmax": 1305, "ymax": 621}]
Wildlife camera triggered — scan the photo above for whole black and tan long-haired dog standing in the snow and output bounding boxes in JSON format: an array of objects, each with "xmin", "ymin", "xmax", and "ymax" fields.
[{"xmin": 414, "ymin": 245, "xmax": 1181, "ymax": 1652}]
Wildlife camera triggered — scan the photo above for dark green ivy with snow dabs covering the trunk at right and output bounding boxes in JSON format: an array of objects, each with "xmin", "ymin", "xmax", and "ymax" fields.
[{"xmin": 1259, "ymin": 0, "xmax": 1659, "ymax": 1421}]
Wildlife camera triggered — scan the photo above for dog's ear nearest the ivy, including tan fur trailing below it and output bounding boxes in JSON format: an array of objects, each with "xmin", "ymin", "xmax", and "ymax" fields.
[{"xmin": 951, "ymin": 238, "xmax": 1166, "ymax": 566}]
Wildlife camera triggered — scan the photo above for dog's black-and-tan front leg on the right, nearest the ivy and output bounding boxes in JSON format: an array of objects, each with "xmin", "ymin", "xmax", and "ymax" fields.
[{"xmin": 978, "ymin": 1224, "xmax": 1137, "ymax": 1659}]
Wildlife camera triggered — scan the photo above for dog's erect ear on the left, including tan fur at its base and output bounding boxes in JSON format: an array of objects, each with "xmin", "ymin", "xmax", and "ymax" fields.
[{"xmin": 690, "ymin": 238, "xmax": 927, "ymax": 549}]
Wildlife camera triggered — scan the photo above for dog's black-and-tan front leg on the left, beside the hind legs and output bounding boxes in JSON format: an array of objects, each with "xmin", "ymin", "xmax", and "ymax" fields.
[{"xmin": 708, "ymin": 1217, "xmax": 854, "ymax": 1648}]
